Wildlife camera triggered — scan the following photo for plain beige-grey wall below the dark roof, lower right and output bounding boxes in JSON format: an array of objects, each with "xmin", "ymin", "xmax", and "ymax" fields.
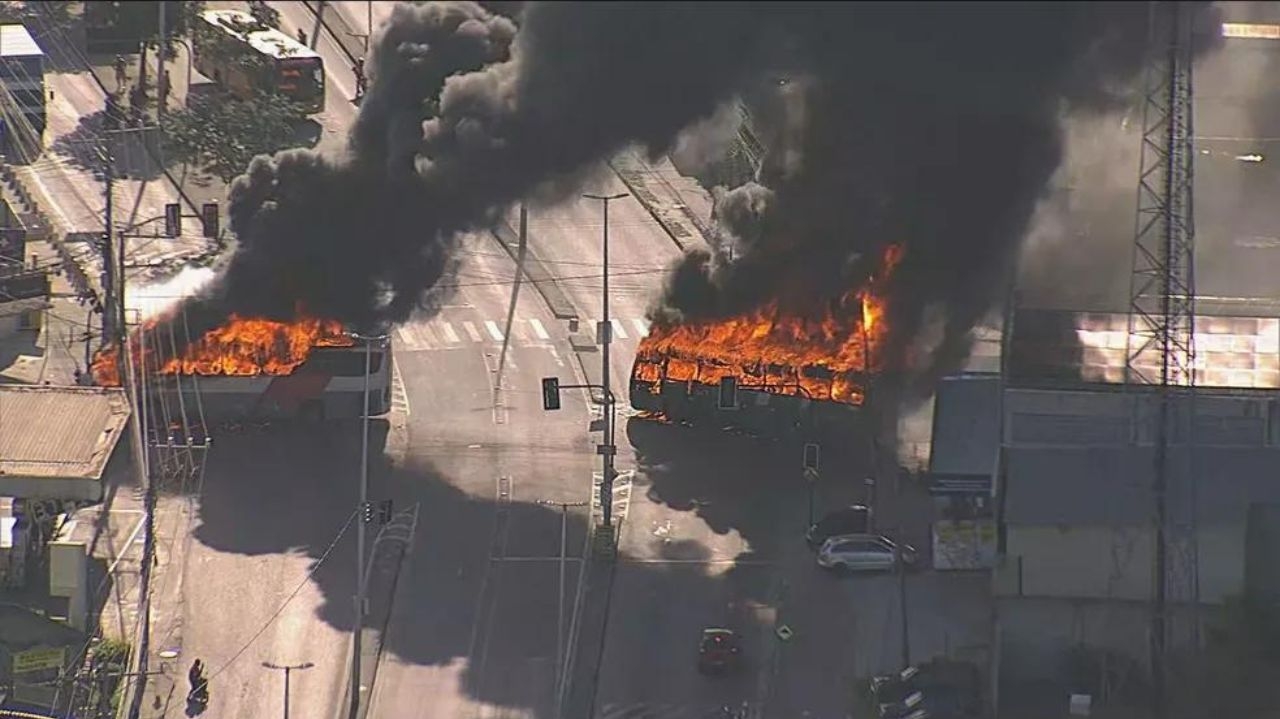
[{"xmin": 996, "ymin": 522, "xmax": 1245, "ymax": 604}]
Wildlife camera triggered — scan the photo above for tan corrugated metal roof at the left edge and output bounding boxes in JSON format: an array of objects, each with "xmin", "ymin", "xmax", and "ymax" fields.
[{"xmin": 0, "ymin": 385, "xmax": 131, "ymax": 480}]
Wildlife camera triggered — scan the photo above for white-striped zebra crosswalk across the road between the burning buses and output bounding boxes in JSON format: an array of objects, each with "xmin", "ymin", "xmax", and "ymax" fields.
[{"xmin": 396, "ymin": 316, "xmax": 649, "ymax": 352}]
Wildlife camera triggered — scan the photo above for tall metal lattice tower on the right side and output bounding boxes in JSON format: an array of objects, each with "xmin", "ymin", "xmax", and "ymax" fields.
[{"xmin": 1125, "ymin": 1, "xmax": 1199, "ymax": 719}]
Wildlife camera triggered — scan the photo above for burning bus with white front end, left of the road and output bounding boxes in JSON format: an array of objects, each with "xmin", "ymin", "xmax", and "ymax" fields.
[{"xmin": 92, "ymin": 315, "xmax": 392, "ymax": 425}]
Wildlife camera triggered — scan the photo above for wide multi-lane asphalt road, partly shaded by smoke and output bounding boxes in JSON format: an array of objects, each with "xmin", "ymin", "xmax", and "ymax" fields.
[{"xmin": 120, "ymin": 3, "xmax": 993, "ymax": 719}]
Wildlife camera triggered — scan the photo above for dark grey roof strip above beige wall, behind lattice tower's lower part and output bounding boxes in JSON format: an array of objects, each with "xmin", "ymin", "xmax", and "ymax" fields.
[{"xmin": 1005, "ymin": 446, "xmax": 1280, "ymax": 526}]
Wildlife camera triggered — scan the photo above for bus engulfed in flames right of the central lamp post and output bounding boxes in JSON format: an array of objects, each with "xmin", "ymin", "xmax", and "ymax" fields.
[{"xmin": 630, "ymin": 246, "xmax": 901, "ymax": 436}]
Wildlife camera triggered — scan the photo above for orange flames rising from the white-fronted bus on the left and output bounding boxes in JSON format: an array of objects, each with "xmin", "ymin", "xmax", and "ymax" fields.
[{"xmin": 92, "ymin": 315, "xmax": 355, "ymax": 386}]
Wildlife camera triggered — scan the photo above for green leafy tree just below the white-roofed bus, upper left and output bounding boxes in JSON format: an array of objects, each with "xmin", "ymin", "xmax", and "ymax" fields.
[{"xmin": 165, "ymin": 93, "xmax": 303, "ymax": 182}]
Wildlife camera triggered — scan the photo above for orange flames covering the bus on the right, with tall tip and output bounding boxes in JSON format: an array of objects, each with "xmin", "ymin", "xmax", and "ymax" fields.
[{"xmin": 632, "ymin": 244, "xmax": 902, "ymax": 404}]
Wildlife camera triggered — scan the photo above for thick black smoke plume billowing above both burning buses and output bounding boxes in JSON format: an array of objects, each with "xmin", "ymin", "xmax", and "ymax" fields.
[{"xmin": 172, "ymin": 3, "xmax": 1218, "ymax": 391}]
